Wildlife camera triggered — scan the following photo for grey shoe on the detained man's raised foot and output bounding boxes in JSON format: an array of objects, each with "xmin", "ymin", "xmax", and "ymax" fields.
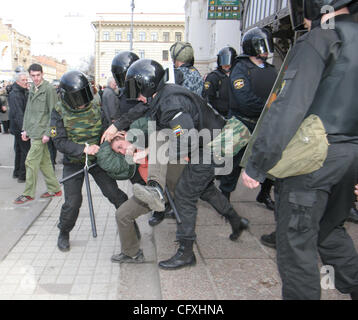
[{"xmin": 133, "ymin": 180, "xmax": 165, "ymax": 212}]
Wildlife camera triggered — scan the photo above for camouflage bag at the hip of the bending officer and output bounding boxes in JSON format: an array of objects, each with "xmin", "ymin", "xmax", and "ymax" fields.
[{"xmin": 208, "ymin": 117, "xmax": 251, "ymax": 157}]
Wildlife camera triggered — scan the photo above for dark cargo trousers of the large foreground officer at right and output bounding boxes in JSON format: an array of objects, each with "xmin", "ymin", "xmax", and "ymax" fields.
[{"xmin": 275, "ymin": 143, "xmax": 358, "ymax": 300}]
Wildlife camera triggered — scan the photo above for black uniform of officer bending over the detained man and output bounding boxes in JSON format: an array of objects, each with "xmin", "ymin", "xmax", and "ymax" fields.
[{"xmin": 150, "ymin": 84, "xmax": 243, "ymax": 240}]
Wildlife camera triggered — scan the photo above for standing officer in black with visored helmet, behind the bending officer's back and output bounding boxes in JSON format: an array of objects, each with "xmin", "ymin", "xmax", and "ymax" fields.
[{"xmin": 220, "ymin": 28, "xmax": 277, "ymax": 210}]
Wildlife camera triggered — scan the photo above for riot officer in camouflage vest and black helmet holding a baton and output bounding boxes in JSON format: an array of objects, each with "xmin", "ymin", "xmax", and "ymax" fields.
[{"xmin": 51, "ymin": 71, "xmax": 128, "ymax": 251}]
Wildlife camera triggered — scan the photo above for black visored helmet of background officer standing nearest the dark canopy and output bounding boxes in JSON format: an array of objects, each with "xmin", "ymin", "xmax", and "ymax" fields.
[{"xmin": 242, "ymin": 27, "xmax": 273, "ymax": 57}]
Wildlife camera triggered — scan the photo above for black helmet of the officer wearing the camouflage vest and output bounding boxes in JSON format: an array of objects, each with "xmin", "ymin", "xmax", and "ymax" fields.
[{"xmin": 59, "ymin": 71, "xmax": 93, "ymax": 109}]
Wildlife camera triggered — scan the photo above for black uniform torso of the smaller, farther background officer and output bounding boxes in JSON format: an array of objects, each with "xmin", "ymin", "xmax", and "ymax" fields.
[{"xmin": 202, "ymin": 69, "xmax": 231, "ymax": 117}]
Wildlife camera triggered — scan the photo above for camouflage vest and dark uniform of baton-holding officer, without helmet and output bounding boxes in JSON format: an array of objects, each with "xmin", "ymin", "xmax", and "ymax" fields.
[{"xmin": 51, "ymin": 102, "xmax": 128, "ymax": 232}]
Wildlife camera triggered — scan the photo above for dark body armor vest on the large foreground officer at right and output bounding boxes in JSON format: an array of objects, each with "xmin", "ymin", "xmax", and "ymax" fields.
[{"xmin": 307, "ymin": 21, "xmax": 358, "ymax": 136}]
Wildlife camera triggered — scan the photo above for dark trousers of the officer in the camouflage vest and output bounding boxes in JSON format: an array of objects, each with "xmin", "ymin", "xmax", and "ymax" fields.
[{"xmin": 58, "ymin": 164, "xmax": 128, "ymax": 232}]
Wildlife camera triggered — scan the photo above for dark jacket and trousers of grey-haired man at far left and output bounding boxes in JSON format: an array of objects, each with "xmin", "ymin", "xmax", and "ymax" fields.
[{"xmin": 8, "ymin": 82, "xmax": 31, "ymax": 181}]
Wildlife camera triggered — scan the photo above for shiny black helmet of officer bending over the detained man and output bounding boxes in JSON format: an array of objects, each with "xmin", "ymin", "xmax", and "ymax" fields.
[{"xmin": 125, "ymin": 59, "xmax": 168, "ymax": 99}]
